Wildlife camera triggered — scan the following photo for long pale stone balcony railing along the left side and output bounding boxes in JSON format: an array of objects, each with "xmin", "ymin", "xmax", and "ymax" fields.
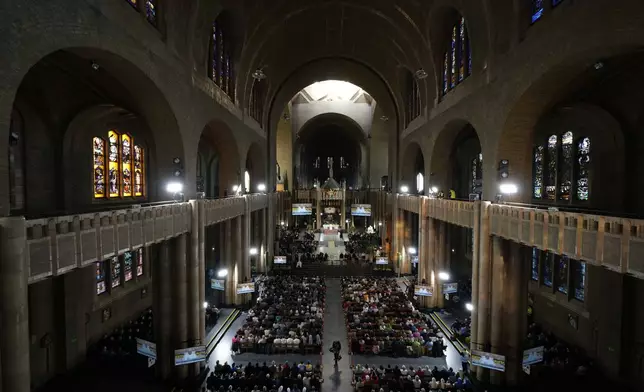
[{"xmin": 26, "ymin": 194, "xmax": 268, "ymax": 283}]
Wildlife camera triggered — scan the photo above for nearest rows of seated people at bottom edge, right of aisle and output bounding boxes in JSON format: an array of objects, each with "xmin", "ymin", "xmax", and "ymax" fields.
[{"xmin": 352, "ymin": 365, "xmax": 472, "ymax": 392}]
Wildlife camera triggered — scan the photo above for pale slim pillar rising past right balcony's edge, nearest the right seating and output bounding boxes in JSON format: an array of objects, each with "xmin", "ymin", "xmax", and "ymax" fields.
[{"xmin": 476, "ymin": 201, "xmax": 492, "ymax": 379}]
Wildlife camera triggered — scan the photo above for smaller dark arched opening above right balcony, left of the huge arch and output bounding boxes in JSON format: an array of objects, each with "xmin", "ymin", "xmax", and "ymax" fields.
[{"xmin": 428, "ymin": 119, "xmax": 483, "ymax": 198}]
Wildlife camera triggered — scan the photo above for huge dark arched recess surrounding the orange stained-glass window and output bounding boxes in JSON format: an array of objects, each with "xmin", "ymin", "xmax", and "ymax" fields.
[{"xmin": 6, "ymin": 47, "xmax": 184, "ymax": 216}]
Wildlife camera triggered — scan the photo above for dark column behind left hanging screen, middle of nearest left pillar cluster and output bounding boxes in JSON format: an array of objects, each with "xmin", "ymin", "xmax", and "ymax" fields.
[{"xmin": 171, "ymin": 234, "xmax": 187, "ymax": 379}]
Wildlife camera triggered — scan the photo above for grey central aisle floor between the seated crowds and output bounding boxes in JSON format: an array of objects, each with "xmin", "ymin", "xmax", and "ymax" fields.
[{"xmin": 322, "ymin": 279, "xmax": 352, "ymax": 392}]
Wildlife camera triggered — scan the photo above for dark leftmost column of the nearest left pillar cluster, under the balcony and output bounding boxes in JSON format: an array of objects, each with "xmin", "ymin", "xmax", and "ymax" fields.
[{"xmin": 155, "ymin": 241, "xmax": 175, "ymax": 380}]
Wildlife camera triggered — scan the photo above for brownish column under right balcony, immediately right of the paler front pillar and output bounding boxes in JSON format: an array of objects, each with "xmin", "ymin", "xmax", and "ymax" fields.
[{"xmin": 490, "ymin": 237, "xmax": 507, "ymax": 385}]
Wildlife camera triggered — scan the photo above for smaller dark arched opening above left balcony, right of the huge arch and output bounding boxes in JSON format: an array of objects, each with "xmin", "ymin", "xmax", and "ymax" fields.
[{"xmin": 197, "ymin": 120, "xmax": 244, "ymax": 197}]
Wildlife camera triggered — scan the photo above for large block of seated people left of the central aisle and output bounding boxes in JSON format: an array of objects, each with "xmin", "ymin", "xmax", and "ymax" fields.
[{"xmin": 232, "ymin": 276, "xmax": 326, "ymax": 354}]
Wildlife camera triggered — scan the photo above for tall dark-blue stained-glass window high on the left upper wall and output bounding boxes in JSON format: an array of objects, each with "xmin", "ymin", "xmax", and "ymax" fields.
[{"xmin": 208, "ymin": 16, "xmax": 236, "ymax": 102}]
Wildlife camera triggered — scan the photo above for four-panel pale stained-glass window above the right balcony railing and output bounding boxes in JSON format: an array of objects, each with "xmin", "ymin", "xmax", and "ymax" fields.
[{"xmin": 532, "ymin": 131, "xmax": 590, "ymax": 202}]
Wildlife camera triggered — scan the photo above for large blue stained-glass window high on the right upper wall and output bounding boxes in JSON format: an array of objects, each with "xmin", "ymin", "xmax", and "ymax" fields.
[{"xmin": 443, "ymin": 16, "xmax": 472, "ymax": 95}]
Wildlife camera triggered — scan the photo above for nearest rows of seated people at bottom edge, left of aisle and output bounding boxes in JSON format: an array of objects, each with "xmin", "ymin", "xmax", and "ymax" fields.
[{"xmin": 204, "ymin": 361, "xmax": 322, "ymax": 392}]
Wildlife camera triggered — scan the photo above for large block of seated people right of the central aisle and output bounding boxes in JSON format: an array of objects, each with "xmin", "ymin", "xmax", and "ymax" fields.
[{"xmin": 342, "ymin": 278, "xmax": 446, "ymax": 357}]
